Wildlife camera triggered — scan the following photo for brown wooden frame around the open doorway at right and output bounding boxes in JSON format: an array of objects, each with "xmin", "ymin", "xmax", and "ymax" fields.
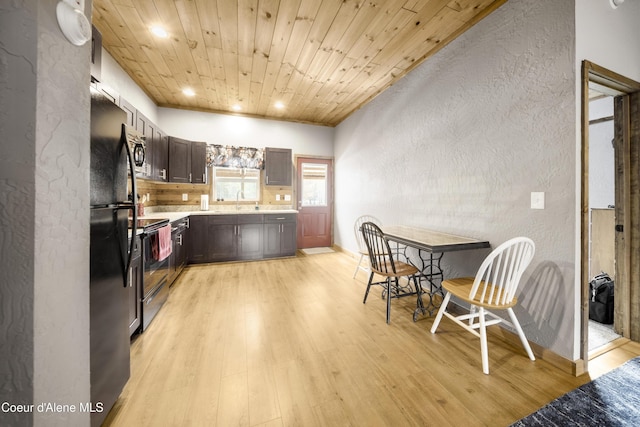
[{"xmin": 577, "ymin": 60, "xmax": 640, "ymax": 374}]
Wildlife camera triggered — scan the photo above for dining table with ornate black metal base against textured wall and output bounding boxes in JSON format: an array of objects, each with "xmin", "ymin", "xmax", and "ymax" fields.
[{"xmin": 381, "ymin": 225, "xmax": 491, "ymax": 322}]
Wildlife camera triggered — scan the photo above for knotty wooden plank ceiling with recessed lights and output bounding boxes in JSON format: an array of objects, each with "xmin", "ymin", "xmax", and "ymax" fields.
[{"xmin": 92, "ymin": 0, "xmax": 506, "ymax": 126}]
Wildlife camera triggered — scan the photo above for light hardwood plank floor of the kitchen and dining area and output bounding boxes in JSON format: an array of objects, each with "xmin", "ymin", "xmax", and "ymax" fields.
[{"xmin": 104, "ymin": 252, "xmax": 640, "ymax": 427}]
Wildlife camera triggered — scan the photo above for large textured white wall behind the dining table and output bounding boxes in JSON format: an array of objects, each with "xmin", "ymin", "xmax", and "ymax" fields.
[{"xmin": 334, "ymin": 0, "xmax": 577, "ymax": 358}]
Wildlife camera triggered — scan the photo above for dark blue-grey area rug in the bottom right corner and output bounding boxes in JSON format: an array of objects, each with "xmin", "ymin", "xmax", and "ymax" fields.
[{"xmin": 512, "ymin": 357, "xmax": 640, "ymax": 427}]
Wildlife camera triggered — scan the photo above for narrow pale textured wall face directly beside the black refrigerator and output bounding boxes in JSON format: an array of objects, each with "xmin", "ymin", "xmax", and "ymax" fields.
[{"xmin": 33, "ymin": 0, "xmax": 91, "ymax": 426}]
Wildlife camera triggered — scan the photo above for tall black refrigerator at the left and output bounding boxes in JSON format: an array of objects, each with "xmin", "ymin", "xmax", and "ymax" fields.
[{"xmin": 90, "ymin": 91, "xmax": 136, "ymax": 426}]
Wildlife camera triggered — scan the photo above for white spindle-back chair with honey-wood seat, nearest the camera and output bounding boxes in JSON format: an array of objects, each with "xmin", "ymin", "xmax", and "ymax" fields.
[{"xmin": 431, "ymin": 237, "xmax": 535, "ymax": 374}]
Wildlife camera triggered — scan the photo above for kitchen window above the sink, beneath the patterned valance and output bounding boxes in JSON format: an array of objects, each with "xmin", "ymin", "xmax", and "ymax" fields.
[{"xmin": 212, "ymin": 166, "xmax": 260, "ymax": 202}]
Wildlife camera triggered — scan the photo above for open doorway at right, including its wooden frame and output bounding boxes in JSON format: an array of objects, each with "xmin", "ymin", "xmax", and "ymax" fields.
[{"xmin": 579, "ymin": 61, "xmax": 640, "ymax": 371}]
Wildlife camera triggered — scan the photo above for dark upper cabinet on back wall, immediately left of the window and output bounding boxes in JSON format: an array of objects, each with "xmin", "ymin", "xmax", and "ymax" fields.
[{"xmin": 169, "ymin": 136, "xmax": 207, "ymax": 184}]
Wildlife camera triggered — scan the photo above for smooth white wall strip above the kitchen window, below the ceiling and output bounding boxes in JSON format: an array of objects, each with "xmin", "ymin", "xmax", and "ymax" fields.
[{"xmin": 158, "ymin": 108, "xmax": 335, "ymax": 157}]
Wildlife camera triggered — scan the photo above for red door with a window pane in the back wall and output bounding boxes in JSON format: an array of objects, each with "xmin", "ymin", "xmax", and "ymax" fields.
[{"xmin": 296, "ymin": 157, "xmax": 333, "ymax": 249}]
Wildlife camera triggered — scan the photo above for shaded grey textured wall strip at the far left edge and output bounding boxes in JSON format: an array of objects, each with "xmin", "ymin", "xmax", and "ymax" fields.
[{"xmin": 0, "ymin": 3, "xmax": 37, "ymax": 425}]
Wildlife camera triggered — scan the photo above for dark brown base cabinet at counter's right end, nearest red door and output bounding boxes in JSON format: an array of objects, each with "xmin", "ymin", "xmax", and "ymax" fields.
[{"xmin": 263, "ymin": 214, "xmax": 297, "ymax": 258}]
